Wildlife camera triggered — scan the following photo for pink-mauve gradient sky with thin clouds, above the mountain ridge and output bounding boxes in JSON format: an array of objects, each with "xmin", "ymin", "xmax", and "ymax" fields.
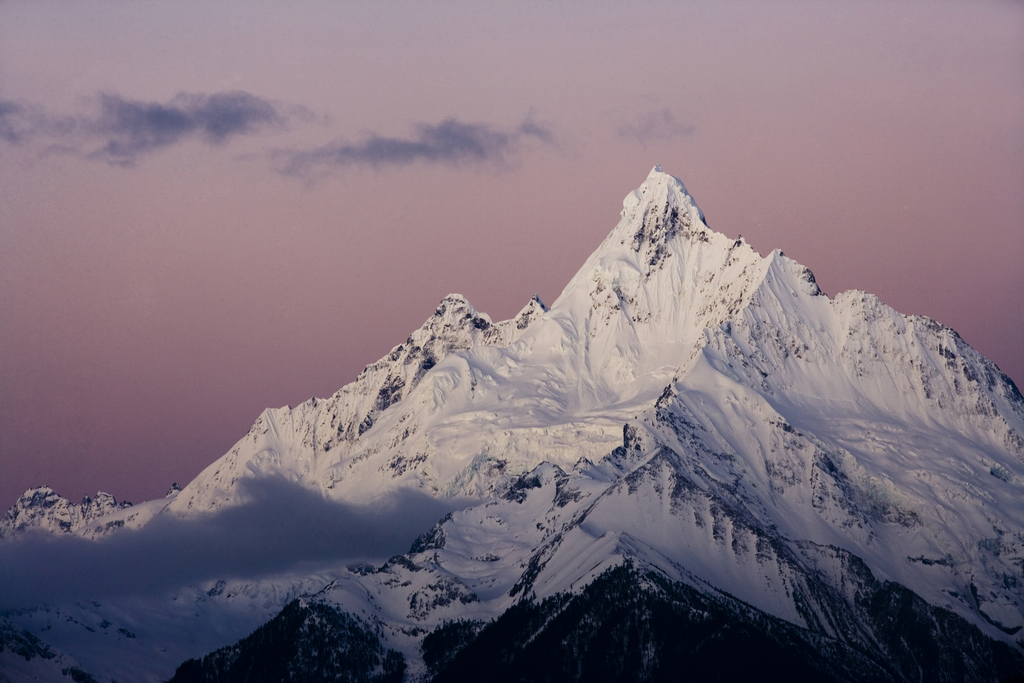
[{"xmin": 0, "ymin": 0, "xmax": 1024, "ymax": 509}]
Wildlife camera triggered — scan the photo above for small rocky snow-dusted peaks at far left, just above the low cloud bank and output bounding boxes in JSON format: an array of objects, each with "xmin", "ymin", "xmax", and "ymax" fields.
[{"xmin": 0, "ymin": 486, "xmax": 131, "ymax": 540}]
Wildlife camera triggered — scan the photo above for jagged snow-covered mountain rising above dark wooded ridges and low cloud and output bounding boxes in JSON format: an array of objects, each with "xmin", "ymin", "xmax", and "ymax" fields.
[{"xmin": 0, "ymin": 167, "xmax": 1024, "ymax": 680}]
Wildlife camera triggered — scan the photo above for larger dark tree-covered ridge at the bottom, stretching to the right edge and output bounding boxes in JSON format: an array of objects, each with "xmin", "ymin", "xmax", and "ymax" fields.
[{"xmin": 423, "ymin": 564, "xmax": 1024, "ymax": 683}]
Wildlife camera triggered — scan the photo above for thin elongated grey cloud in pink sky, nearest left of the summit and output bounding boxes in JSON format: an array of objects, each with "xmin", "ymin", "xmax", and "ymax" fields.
[{"xmin": 274, "ymin": 119, "xmax": 554, "ymax": 177}]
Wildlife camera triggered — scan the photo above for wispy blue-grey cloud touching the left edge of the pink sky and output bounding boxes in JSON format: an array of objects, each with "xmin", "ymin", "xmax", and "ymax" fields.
[{"xmin": 0, "ymin": 91, "xmax": 288, "ymax": 167}]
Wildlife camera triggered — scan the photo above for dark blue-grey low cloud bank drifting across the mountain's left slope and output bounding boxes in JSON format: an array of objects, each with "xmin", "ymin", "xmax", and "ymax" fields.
[{"xmin": 0, "ymin": 478, "xmax": 459, "ymax": 610}]
